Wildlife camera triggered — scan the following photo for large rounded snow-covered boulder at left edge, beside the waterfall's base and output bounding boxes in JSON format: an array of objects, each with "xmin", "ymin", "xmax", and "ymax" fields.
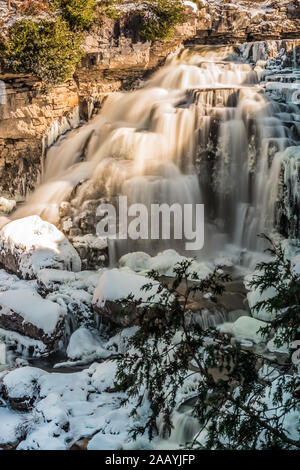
[{"xmin": 0, "ymin": 216, "xmax": 81, "ymax": 279}]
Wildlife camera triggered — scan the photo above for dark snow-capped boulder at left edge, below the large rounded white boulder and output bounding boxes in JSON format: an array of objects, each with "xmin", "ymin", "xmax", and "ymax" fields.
[{"xmin": 0, "ymin": 289, "xmax": 65, "ymax": 352}]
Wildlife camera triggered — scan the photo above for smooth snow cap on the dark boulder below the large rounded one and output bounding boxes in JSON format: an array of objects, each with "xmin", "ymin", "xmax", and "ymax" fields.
[{"xmin": 0, "ymin": 289, "xmax": 64, "ymax": 335}]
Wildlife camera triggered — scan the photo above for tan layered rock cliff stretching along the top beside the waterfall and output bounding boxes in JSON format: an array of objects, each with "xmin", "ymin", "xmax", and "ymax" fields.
[{"xmin": 0, "ymin": 0, "xmax": 300, "ymax": 199}]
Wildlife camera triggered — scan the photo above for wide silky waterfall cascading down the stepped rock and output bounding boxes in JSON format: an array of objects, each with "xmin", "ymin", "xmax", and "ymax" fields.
[{"xmin": 15, "ymin": 47, "xmax": 296, "ymax": 268}]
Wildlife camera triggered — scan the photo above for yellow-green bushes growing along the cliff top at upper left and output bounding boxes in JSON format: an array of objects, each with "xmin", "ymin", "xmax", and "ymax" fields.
[{"xmin": 0, "ymin": 0, "xmax": 189, "ymax": 85}]
